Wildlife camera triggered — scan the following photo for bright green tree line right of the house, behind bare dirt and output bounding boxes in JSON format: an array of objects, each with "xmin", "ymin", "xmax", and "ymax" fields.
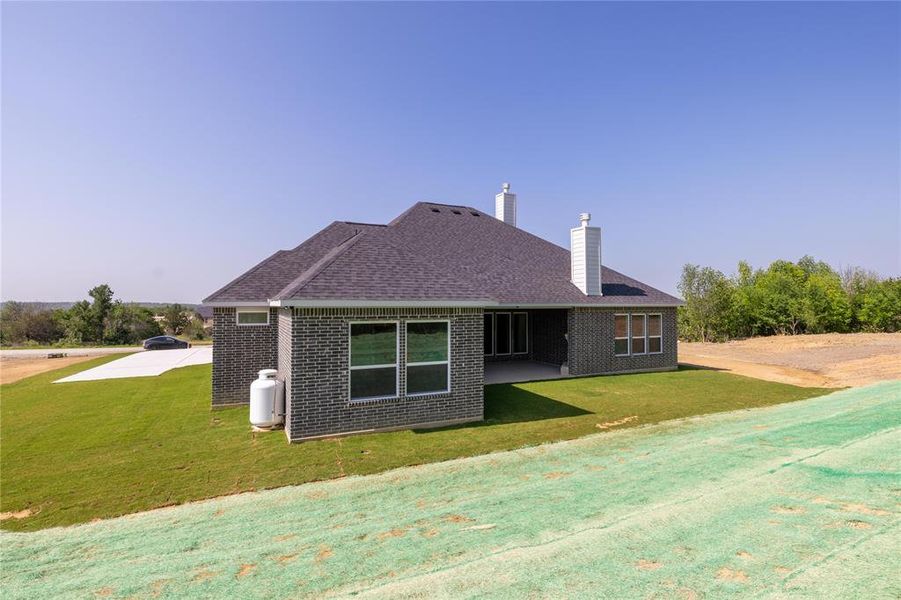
[{"xmin": 679, "ymin": 256, "xmax": 901, "ymax": 342}]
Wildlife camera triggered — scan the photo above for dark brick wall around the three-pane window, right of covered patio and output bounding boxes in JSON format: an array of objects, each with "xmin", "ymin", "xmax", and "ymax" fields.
[{"xmin": 568, "ymin": 307, "xmax": 677, "ymax": 375}]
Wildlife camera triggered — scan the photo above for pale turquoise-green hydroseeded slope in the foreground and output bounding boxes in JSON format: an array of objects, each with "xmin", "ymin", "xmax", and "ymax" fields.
[{"xmin": 0, "ymin": 382, "xmax": 901, "ymax": 599}]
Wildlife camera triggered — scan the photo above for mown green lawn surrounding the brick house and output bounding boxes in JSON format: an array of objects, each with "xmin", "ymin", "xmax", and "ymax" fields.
[{"xmin": 0, "ymin": 357, "xmax": 834, "ymax": 530}]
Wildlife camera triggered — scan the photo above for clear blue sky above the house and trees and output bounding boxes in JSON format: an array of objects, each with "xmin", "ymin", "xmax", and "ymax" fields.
[{"xmin": 2, "ymin": 2, "xmax": 901, "ymax": 302}]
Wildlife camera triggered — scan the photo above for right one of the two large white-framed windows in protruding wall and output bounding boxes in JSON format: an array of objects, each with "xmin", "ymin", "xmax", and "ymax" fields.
[{"xmin": 407, "ymin": 321, "xmax": 450, "ymax": 396}]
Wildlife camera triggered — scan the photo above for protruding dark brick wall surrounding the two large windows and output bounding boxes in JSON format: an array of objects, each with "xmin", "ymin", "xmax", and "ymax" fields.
[{"xmin": 285, "ymin": 308, "xmax": 484, "ymax": 441}]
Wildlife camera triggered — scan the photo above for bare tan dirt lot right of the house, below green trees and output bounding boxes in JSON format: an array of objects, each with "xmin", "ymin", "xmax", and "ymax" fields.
[{"xmin": 679, "ymin": 333, "xmax": 901, "ymax": 387}]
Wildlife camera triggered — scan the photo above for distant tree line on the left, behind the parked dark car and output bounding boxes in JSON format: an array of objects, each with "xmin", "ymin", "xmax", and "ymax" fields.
[{"xmin": 0, "ymin": 284, "xmax": 206, "ymax": 345}]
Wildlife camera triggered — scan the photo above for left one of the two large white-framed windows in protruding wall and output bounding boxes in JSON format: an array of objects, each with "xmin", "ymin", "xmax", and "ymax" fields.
[{"xmin": 350, "ymin": 322, "xmax": 397, "ymax": 400}]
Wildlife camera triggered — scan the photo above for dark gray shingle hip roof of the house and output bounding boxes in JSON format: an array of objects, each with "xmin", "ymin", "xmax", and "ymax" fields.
[{"xmin": 204, "ymin": 202, "xmax": 680, "ymax": 306}]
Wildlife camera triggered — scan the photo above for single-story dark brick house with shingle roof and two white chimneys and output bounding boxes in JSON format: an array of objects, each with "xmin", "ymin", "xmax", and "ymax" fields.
[{"xmin": 203, "ymin": 184, "xmax": 680, "ymax": 441}]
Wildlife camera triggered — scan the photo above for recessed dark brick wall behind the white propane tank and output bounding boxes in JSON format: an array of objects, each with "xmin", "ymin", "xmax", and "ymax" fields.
[{"xmin": 213, "ymin": 307, "xmax": 278, "ymax": 406}]
